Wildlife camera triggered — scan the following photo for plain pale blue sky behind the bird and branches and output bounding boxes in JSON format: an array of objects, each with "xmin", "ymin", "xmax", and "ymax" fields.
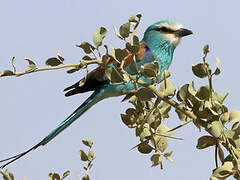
[{"xmin": 0, "ymin": 0, "xmax": 240, "ymax": 180}]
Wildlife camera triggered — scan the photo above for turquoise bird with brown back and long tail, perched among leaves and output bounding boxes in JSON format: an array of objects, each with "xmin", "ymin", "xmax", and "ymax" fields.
[{"xmin": 0, "ymin": 20, "xmax": 192, "ymax": 168}]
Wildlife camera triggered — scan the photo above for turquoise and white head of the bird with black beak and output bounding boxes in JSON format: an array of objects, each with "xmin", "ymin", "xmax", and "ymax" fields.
[{"xmin": 143, "ymin": 20, "xmax": 192, "ymax": 48}]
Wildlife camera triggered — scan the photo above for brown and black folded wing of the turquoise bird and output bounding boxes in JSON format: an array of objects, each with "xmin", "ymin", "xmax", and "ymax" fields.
[{"xmin": 64, "ymin": 43, "xmax": 148, "ymax": 96}]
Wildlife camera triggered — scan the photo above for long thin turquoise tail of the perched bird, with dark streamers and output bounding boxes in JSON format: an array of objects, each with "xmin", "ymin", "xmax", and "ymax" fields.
[{"xmin": 0, "ymin": 91, "xmax": 102, "ymax": 168}]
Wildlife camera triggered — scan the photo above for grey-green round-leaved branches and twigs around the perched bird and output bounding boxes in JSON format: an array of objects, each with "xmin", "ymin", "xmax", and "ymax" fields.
[{"xmin": 0, "ymin": 14, "xmax": 240, "ymax": 180}]
